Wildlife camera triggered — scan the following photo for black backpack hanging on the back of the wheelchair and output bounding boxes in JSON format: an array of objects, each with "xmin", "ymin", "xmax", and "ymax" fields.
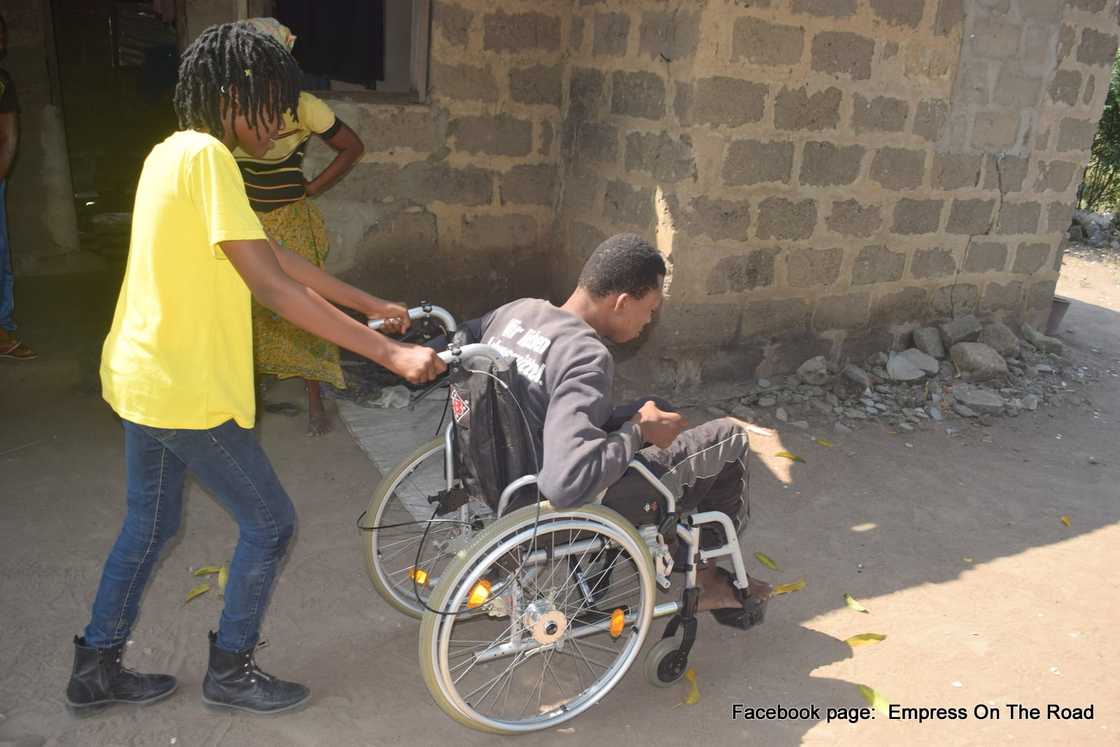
[{"xmin": 448, "ymin": 328, "xmax": 540, "ymax": 513}]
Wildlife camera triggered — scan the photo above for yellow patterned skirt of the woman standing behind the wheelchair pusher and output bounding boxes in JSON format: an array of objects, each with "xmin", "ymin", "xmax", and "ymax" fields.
[{"xmin": 253, "ymin": 199, "xmax": 346, "ymax": 389}]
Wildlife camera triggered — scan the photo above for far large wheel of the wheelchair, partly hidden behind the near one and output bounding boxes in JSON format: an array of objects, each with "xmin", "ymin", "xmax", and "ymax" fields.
[{"xmin": 362, "ymin": 438, "xmax": 492, "ymax": 619}]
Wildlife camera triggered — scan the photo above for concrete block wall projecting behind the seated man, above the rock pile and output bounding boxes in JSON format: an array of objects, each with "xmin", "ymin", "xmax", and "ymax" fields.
[{"xmin": 553, "ymin": 0, "xmax": 1117, "ymax": 386}]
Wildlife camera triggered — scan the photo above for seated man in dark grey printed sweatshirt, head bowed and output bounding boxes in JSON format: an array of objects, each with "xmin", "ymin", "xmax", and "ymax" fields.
[{"xmin": 470, "ymin": 234, "xmax": 771, "ymax": 628}]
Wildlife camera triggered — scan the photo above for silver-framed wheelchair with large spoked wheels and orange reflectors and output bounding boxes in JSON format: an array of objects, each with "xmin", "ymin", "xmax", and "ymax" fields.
[{"xmin": 363, "ymin": 306, "xmax": 765, "ymax": 734}]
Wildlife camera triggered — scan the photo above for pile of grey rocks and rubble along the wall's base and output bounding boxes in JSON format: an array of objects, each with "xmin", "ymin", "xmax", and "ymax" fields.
[{"xmin": 725, "ymin": 316, "xmax": 1085, "ymax": 432}]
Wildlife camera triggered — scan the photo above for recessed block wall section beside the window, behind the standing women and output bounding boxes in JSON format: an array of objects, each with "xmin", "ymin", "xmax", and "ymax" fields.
[{"xmin": 307, "ymin": 0, "xmax": 570, "ymax": 315}]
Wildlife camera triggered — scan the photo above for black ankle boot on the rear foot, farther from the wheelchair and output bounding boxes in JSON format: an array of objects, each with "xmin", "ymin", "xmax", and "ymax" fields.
[{"xmin": 66, "ymin": 636, "xmax": 178, "ymax": 708}]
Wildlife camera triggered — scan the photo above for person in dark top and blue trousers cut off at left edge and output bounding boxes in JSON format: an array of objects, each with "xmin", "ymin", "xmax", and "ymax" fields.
[{"xmin": 0, "ymin": 16, "xmax": 38, "ymax": 361}]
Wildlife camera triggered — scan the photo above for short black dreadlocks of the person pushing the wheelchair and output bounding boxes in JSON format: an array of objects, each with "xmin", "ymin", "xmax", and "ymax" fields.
[{"xmin": 175, "ymin": 21, "xmax": 302, "ymax": 137}]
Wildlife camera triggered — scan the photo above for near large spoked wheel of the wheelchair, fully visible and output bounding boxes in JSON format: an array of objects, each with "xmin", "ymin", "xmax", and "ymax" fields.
[{"xmin": 420, "ymin": 504, "xmax": 655, "ymax": 734}]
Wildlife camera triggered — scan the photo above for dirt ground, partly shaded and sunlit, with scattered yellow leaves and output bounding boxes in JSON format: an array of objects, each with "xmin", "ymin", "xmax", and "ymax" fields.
[{"xmin": 0, "ymin": 253, "xmax": 1120, "ymax": 746}]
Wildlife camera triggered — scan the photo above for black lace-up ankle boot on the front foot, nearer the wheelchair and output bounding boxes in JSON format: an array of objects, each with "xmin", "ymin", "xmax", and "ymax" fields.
[{"xmin": 203, "ymin": 631, "xmax": 311, "ymax": 713}]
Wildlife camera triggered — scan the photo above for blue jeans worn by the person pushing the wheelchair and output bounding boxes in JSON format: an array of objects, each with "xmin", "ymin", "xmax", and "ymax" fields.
[{"xmin": 85, "ymin": 420, "xmax": 296, "ymax": 652}]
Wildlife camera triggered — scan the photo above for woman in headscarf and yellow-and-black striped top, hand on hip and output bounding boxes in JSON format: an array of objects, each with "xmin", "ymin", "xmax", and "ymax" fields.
[{"xmin": 233, "ymin": 18, "xmax": 364, "ymax": 436}]
